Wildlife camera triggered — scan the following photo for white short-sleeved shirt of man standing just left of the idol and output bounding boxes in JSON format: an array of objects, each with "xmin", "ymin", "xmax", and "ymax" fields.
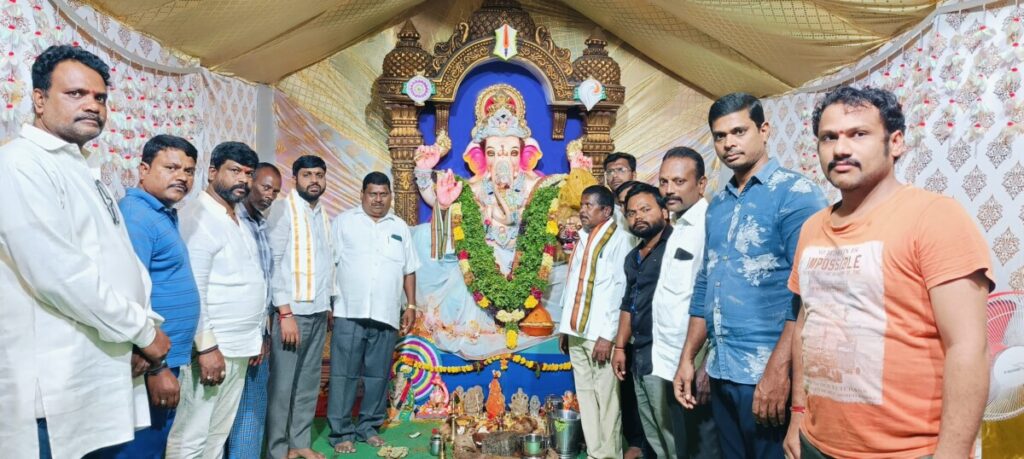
[{"xmin": 332, "ymin": 207, "xmax": 420, "ymax": 329}]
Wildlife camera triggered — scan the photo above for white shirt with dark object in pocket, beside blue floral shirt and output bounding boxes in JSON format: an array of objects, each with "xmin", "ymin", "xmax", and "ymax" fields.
[{"xmin": 651, "ymin": 199, "xmax": 708, "ymax": 381}]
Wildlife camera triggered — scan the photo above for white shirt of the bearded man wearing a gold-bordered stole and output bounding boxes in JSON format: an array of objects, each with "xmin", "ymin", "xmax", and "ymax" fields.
[{"xmin": 267, "ymin": 196, "xmax": 335, "ymax": 316}]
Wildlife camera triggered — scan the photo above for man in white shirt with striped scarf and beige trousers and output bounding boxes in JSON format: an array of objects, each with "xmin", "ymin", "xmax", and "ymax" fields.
[{"xmin": 558, "ymin": 184, "xmax": 633, "ymax": 459}]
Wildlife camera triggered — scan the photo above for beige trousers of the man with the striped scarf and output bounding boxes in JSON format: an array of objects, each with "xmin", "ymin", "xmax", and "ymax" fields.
[{"xmin": 569, "ymin": 336, "xmax": 623, "ymax": 459}]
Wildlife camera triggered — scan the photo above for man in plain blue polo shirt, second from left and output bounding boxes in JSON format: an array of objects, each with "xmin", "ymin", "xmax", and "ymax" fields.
[{"xmin": 100, "ymin": 135, "xmax": 200, "ymax": 459}]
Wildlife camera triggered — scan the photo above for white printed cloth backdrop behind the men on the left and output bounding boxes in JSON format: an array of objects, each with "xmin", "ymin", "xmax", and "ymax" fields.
[{"xmin": 0, "ymin": 0, "xmax": 256, "ymax": 197}]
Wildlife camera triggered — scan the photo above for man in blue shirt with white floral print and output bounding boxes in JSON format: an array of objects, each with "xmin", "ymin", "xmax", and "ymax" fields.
[{"xmin": 675, "ymin": 93, "xmax": 826, "ymax": 458}]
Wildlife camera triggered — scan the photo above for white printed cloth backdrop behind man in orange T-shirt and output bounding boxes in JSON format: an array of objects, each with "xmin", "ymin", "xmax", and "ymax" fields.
[{"xmin": 765, "ymin": 4, "xmax": 1024, "ymax": 291}]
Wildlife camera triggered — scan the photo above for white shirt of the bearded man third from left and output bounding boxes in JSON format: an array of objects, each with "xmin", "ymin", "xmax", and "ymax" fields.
[{"xmin": 181, "ymin": 192, "xmax": 266, "ymax": 358}]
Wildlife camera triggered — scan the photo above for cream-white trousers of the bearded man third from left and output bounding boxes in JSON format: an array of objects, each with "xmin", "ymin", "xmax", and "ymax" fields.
[{"xmin": 166, "ymin": 357, "xmax": 249, "ymax": 459}]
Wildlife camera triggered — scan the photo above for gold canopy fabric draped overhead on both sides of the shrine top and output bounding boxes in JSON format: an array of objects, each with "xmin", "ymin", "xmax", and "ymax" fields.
[{"xmin": 85, "ymin": 0, "xmax": 938, "ymax": 96}]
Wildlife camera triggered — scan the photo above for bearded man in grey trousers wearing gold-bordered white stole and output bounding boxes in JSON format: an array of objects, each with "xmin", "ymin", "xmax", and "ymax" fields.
[{"xmin": 265, "ymin": 155, "xmax": 336, "ymax": 459}]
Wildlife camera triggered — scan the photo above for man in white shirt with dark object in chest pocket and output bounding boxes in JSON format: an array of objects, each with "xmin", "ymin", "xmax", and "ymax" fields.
[{"xmin": 651, "ymin": 147, "xmax": 721, "ymax": 458}]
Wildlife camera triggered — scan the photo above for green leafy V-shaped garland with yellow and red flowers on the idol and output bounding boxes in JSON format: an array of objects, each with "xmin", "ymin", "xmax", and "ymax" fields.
[{"xmin": 451, "ymin": 178, "xmax": 559, "ymax": 349}]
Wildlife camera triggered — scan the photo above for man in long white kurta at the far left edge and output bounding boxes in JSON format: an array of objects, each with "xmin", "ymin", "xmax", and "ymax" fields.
[{"xmin": 0, "ymin": 46, "xmax": 170, "ymax": 458}]
